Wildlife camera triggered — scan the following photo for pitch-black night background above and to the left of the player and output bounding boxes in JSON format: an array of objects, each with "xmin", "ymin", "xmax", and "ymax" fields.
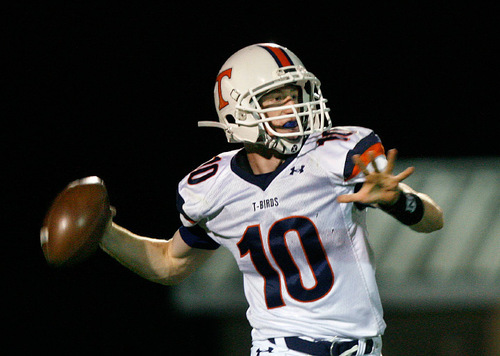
[{"xmin": 1, "ymin": 1, "xmax": 500, "ymax": 354}]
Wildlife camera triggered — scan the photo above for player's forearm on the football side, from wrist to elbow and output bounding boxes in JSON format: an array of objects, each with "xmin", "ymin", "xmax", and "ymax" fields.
[{"xmin": 101, "ymin": 223, "xmax": 171, "ymax": 284}]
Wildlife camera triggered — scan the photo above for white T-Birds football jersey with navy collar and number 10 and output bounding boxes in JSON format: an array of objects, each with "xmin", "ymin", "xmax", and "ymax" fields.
[{"xmin": 177, "ymin": 127, "xmax": 385, "ymax": 340}]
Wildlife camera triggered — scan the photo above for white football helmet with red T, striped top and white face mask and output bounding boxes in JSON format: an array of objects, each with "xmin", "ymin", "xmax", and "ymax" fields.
[{"xmin": 198, "ymin": 43, "xmax": 332, "ymax": 154}]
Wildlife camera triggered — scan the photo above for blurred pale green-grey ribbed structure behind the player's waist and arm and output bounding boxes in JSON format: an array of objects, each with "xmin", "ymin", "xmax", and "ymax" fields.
[{"xmin": 173, "ymin": 158, "xmax": 500, "ymax": 314}]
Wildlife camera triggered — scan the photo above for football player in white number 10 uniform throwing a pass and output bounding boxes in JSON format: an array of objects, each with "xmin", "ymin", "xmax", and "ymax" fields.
[{"xmin": 102, "ymin": 44, "xmax": 443, "ymax": 356}]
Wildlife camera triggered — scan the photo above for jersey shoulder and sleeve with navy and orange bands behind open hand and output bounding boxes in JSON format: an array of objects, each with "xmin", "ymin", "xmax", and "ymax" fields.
[{"xmin": 317, "ymin": 126, "xmax": 387, "ymax": 184}]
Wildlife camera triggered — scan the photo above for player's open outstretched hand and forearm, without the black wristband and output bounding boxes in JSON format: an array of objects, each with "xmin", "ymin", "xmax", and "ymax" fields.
[{"xmin": 337, "ymin": 150, "xmax": 444, "ymax": 233}]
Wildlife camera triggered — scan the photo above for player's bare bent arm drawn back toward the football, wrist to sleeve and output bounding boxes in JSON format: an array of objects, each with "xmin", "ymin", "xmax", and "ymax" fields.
[{"xmin": 101, "ymin": 223, "xmax": 213, "ymax": 285}]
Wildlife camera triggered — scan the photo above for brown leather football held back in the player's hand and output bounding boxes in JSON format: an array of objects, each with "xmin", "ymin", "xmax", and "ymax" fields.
[{"xmin": 40, "ymin": 176, "xmax": 112, "ymax": 267}]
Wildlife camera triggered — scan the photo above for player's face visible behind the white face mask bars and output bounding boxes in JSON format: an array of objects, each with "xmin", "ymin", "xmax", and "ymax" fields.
[{"xmin": 259, "ymin": 85, "xmax": 300, "ymax": 133}]
